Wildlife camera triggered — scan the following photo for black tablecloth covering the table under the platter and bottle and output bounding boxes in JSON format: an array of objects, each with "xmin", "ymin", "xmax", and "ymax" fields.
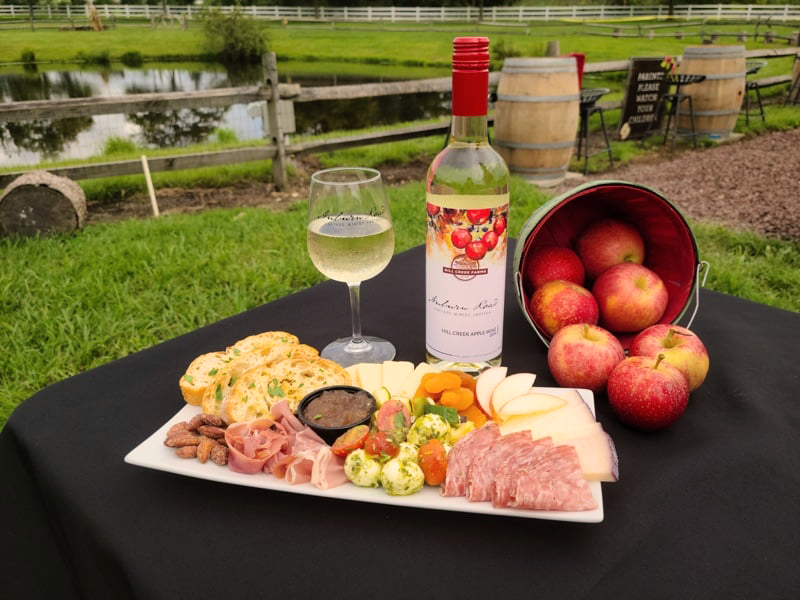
[{"xmin": 0, "ymin": 247, "xmax": 800, "ymax": 599}]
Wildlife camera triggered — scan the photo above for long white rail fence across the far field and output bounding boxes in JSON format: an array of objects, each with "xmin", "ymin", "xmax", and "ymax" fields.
[{"xmin": 0, "ymin": 4, "xmax": 800, "ymax": 23}]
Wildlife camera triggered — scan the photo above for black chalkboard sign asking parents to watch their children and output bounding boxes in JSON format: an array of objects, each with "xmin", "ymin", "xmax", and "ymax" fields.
[{"xmin": 619, "ymin": 57, "xmax": 669, "ymax": 140}]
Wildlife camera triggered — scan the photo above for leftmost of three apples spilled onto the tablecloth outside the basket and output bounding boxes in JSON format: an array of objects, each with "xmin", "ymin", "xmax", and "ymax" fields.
[{"xmin": 547, "ymin": 323, "xmax": 625, "ymax": 393}]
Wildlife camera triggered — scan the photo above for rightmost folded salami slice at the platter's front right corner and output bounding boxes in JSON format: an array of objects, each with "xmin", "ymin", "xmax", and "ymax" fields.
[{"xmin": 508, "ymin": 444, "xmax": 597, "ymax": 511}]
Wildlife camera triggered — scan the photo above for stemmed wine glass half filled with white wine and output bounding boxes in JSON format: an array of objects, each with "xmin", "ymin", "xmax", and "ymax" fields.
[{"xmin": 306, "ymin": 167, "xmax": 395, "ymax": 367}]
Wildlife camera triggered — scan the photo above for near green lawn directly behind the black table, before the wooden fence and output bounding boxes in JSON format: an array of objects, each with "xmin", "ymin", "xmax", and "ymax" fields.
[{"xmin": 0, "ymin": 171, "xmax": 800, "ymax": 425}]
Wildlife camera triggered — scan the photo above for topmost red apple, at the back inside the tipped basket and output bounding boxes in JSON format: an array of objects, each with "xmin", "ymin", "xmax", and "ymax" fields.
[{"xmin": 575, "ymin": 218, "xmax": 644, "ymax": 279}]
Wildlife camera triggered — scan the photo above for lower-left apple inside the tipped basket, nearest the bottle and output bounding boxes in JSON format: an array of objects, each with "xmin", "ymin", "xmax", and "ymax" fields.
[{"xmin": 528, "ymin": 279, "xmax": 598, "ymax": 335}]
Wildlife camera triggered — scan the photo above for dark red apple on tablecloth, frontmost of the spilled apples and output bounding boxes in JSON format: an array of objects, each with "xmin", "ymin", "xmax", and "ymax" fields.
[{"xmin": 607, "ymin": 354, "xmax": 689, "ymax": 431}]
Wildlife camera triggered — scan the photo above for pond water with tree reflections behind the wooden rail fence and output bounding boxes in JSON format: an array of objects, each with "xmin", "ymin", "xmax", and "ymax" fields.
[{"xmin": 0, "ymin": 65, "xmax": 450, "ymax": 167}]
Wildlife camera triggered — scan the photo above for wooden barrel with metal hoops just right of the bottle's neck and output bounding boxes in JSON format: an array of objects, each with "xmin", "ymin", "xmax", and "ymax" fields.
[{"xmin": 494, "ymin": 57, "xmax": 580, "ymax": 187}]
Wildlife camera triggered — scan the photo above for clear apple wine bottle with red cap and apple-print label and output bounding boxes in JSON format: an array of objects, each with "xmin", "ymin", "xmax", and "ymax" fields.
[{"xmin": 425, "ymin": 37, "xmax": 509, "ymax": 371}]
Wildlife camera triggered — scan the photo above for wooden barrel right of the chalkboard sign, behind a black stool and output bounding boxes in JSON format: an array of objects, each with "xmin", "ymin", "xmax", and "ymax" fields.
[{"xmin": 678, "ymin": 46, "xmax": 746, "ymax": 137}]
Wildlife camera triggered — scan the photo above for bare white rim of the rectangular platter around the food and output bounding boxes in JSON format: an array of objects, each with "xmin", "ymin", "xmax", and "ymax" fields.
[{"xmin": 125, "ymin": 388, "xmax": 603, "ymax": 523}]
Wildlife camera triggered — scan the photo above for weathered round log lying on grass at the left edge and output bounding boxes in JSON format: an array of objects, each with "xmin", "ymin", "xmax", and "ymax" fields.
[{"xmin": 0, "ymin": 171, "xmax": 87, "ymax": 236}]
